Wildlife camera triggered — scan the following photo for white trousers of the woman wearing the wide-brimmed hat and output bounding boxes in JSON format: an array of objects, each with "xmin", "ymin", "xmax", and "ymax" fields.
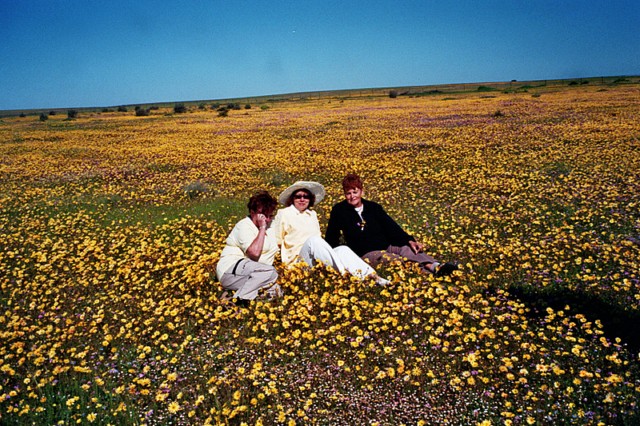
[{"xmin": 300, "ymin": 236, "xmax": 376, "ymax": 279}]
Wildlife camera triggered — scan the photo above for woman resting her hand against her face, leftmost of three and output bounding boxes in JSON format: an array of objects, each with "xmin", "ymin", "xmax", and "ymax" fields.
[{"xmin": 216, "ymin": 191, "xmax": 282, "ymax": 306}]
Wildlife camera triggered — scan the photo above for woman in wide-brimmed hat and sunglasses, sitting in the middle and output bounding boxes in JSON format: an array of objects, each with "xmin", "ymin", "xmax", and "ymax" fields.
[{"xmin": 273, "ymin": 181, "xmax": 388, "ymax": 285}]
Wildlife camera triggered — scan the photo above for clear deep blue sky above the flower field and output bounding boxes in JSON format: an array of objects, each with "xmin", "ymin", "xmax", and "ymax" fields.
[{"xmin": 0, "ymin": 0, "xmax": 640, "ymax": 110}]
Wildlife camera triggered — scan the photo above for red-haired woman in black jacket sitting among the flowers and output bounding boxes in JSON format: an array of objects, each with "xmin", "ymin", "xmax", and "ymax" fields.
[{"xmin": 325, "ymin": 174, "xmax": 458, "ymax": 277}]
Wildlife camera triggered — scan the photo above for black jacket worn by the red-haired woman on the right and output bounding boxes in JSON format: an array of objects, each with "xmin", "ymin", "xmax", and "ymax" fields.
[{"xmin": 325, "ymin": 199, "xmax": 414, "ymax": 256}]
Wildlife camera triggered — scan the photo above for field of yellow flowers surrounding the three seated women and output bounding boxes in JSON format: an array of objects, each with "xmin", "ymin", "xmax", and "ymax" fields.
[{"xmin": 0, "ymin": 84, "xmax": 640, "ymax": 425}]
